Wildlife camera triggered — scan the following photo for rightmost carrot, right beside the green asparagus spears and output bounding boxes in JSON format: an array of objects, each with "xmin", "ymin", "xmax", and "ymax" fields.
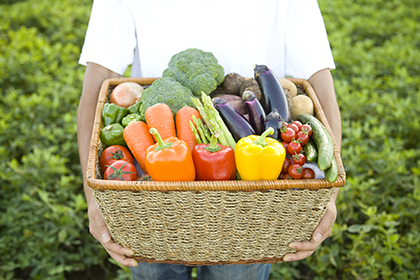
[{"xmin": 175, "ymin": 106, "xmax": 200, "ymax": 152}]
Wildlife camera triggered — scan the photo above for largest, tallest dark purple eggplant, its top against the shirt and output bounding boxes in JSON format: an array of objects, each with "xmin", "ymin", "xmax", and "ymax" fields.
[{"xmin": 254, "ymin": 65, "xmax": 291, "ymax": 122}]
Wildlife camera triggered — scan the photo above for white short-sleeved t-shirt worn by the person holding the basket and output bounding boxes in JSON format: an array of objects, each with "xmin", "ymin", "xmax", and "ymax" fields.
[{"xmin": 79, "ymin": 0, "xmax": 335, "ymax": 79}]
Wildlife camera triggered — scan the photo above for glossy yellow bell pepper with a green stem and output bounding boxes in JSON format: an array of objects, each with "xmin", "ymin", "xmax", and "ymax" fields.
[{"xmin": 235, "ymin": 127, "xmax": 286, "ymax": 180}]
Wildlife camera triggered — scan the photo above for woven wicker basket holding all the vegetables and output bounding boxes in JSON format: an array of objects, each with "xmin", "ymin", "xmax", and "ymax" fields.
[{"xmin": 87, "ymin": 78, "xmax": 345, "ymax": 266}]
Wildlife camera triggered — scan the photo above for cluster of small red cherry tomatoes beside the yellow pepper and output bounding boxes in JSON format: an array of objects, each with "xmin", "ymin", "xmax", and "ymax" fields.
[{"xmin": 280, "ymin": 121, "xmax": 315, "ymax": 180}]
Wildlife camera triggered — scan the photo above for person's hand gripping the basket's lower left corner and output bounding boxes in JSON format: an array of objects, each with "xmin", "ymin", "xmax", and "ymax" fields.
[{"xmin": 88, "ymin": 198, "xmax": 137, "ymax": 267}]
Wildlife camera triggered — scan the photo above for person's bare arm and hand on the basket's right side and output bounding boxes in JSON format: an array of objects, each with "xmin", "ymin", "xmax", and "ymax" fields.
[{"xmin": 283, "ymin": 69, "xmax": 341, "ymax": 261}]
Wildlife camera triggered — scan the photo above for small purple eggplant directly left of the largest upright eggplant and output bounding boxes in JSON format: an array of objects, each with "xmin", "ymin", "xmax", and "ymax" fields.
[{"xmin": 242, "ymin": 90, "xmax": 265, "ymax": 135}]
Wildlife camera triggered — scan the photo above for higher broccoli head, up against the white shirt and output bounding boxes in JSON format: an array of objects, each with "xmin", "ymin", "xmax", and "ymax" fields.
[{"xmin": 162, "ymin": 48, "xmax": 225, "ymax": 96}]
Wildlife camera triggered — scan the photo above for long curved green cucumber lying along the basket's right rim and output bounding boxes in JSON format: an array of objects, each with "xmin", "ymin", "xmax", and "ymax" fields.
[{"xmin": 297, "ymin": 114, "xmax": 334, "ymax": 171}]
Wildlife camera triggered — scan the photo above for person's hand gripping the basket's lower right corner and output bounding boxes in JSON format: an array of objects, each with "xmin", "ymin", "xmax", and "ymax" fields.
[{"xmin": 283, "ymin": 192, "xmax": 337, "ymax": 262}]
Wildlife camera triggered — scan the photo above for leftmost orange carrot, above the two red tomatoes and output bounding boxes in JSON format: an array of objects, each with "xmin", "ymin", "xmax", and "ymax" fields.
[{"xmin": 123, "ymin": 121, "xmax": 155, "ymax": 174}]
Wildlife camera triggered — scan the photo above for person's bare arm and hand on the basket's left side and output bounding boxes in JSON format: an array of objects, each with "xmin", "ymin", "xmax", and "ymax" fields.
[{"xmin": 77, "ymin": 63, "xmax": 137, "ymax": 266}]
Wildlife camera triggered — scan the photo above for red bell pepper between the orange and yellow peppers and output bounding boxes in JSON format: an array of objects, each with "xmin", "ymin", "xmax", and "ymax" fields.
[{"xmin": 192, "ymin": 133, "xmax": 236, "ymax": 181}]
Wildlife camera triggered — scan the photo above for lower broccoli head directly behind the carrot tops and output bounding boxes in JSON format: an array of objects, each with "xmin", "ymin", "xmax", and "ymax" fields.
[{"xmin": 139, "ymin": 78, "xmax": 194, "ymax": 121}]
